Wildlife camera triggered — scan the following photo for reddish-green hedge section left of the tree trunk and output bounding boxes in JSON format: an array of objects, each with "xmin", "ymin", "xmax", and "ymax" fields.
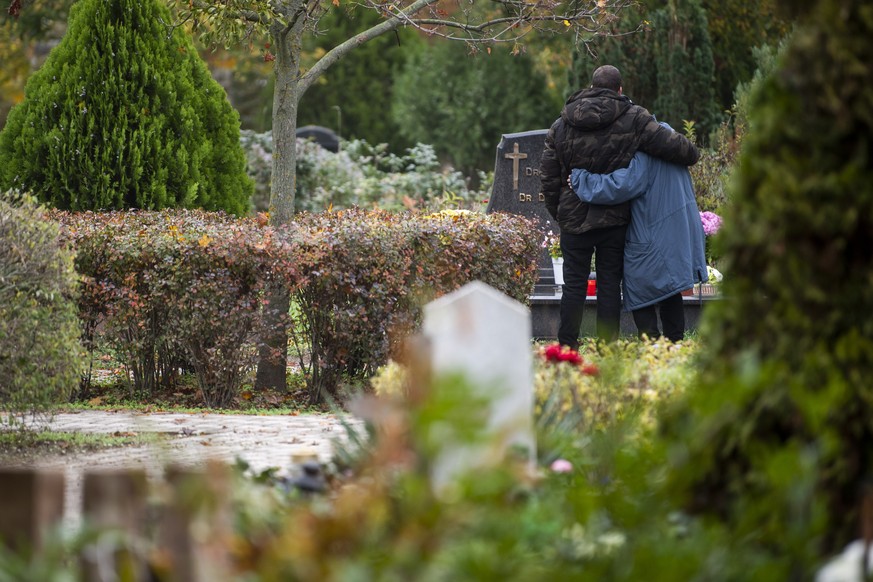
[{"xmin": 59, "ymin": 211, "xmax": 296, "ymax": 407}]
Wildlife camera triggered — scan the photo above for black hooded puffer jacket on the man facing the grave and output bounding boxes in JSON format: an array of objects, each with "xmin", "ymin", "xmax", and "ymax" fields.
[{"xmin": 540, "ymin": 88, "xmax": 700, "ymax": 234}]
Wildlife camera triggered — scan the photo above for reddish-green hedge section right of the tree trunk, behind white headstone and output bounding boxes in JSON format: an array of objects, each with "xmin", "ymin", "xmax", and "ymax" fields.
[{"xmin": 293, "ymin": 209, "xmax": 539, "ymax": 402}]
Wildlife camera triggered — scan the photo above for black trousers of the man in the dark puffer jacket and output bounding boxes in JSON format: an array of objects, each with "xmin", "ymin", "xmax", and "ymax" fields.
[{"xmin": 558, "ymin": 225, "xmax": 627, "ymax": 349}]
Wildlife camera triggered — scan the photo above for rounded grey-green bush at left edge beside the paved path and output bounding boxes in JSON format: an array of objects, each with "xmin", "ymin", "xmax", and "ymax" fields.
[{"xmin": 0, "ymin": 194, "xmax": 82, "ymax": 424}]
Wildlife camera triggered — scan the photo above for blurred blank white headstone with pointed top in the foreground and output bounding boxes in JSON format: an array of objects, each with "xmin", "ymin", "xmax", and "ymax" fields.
[{"xmin": 423, "ymin": 281, "xmax": 536, "ymax": 498}]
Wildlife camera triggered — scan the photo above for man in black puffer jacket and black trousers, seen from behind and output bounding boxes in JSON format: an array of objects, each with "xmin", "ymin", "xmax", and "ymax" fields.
[{"xmin": 540, "ymin": 65, "xmax": 700, "ymax": 349}]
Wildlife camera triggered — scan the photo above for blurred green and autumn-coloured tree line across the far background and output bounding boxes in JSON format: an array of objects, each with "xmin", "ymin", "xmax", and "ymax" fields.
[{"xmin": 0, "ymin": 0, "xmax": 788, "ymax": 175}]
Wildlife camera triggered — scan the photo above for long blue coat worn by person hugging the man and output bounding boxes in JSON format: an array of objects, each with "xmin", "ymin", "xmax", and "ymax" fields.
[{"xmin": 570, "ymin": 152, "xmax": 708, "ymax": 311}]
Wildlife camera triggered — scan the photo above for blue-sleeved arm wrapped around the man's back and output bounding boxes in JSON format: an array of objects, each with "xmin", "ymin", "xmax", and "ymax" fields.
[{"xmin": 569, "ymin": 152, "xmax": 650, "ymax": 206}]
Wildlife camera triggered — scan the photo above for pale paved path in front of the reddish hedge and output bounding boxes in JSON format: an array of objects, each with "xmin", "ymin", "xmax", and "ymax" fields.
[{"xmin": 7, "ymin": 410, "xmax": 360, "ymax": 525}]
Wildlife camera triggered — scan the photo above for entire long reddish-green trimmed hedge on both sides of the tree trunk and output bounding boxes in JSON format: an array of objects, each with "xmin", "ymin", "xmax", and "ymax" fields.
[{"xmin": 57, "ymin": 209, "xmax": 539, "ymax": 406}]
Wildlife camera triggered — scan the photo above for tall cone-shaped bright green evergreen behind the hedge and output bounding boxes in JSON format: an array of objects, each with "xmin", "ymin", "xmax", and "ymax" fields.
[{"xmin": 0, "ymin": 0, "xmax": 252, "ymax": 214}]
